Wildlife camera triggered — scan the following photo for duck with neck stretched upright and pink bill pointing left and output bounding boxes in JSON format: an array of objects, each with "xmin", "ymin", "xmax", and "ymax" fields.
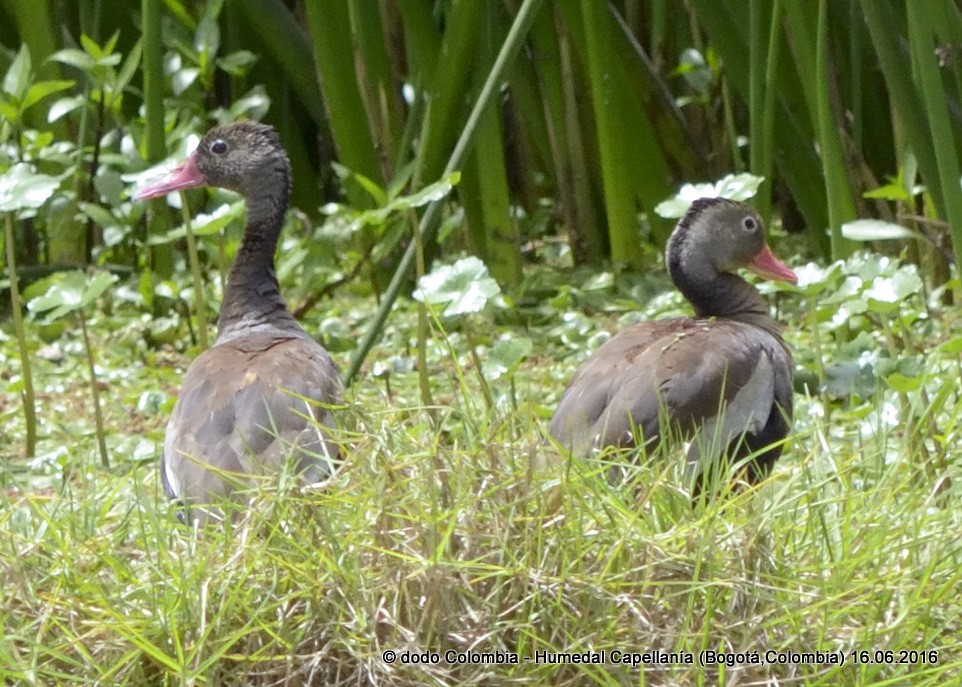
[{"xmin": 136, "ymin": 121, "xmax": 343, "ymax": 524}]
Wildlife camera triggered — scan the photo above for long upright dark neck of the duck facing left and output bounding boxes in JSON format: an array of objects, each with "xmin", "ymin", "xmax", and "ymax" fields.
[{"xmin": 217, "ymin": 177, "xmax": 297, "ymax": 338}]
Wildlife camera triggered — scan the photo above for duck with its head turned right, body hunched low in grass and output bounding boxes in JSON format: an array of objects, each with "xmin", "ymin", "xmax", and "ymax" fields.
[{"xmin": 548, "ymin": 198, "xmax": 798, "ymax": 497}]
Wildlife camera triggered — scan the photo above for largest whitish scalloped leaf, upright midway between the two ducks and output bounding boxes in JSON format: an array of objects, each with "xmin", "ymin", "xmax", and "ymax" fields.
[{"xmin": 414, "ymin": 255, "xmax": 501, "ymax": 317}]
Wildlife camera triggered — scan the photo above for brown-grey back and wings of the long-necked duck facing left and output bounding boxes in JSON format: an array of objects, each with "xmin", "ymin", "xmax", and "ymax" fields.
[{"xmin": 162, "ymin": 339, "xmax": 341, "ymax": 503}]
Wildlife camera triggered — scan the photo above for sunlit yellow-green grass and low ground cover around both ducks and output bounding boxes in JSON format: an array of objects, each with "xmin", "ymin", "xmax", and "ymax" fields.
[{"xmin": 0, "ymin": 262, "xmax": 962, "ymax": 685}]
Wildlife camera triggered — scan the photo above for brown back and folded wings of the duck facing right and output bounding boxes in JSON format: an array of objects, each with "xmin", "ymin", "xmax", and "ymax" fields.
[{"xmin": 549, "ymin": 318, "xmax": 792, "ymax": 478}]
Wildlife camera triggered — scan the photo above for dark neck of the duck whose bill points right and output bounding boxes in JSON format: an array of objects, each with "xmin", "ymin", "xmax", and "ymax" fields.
[{"xmin": 668, "ymin": 251, "xmax": 780, "ymax": 336}]
